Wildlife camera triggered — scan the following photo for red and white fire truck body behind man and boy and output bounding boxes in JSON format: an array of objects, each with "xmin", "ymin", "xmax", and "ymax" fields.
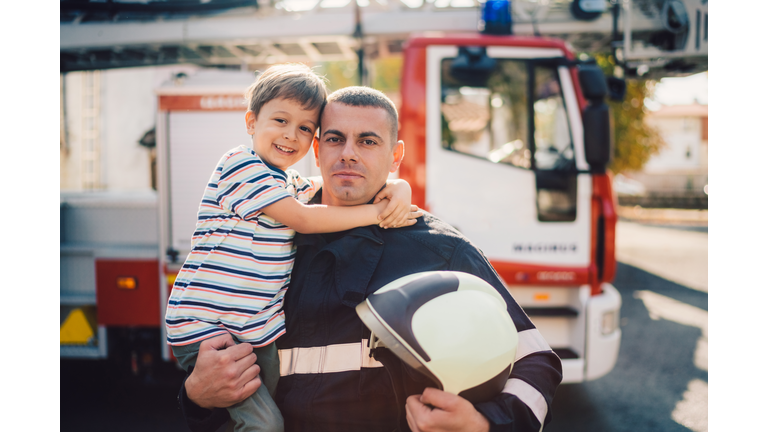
[{"xmin": 61, "ymin": 2, "xmax": 680, "ymax": 383}]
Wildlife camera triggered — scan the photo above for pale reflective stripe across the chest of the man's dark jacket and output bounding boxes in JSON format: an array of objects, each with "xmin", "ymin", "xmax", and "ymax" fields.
[{"xmin": 278, "ymin": 339, "xmax": 383, "ymax": 376}]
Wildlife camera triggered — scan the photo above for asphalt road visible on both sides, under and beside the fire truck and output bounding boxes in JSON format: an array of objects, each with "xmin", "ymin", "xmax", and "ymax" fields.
[{"xmin": 60, "ymin": 222, "xmax": 708, "ymax": 432}]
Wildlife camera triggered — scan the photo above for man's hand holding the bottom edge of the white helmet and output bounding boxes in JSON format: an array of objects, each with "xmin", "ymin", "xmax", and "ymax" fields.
[{"xmin": 405, "ymin": 387, "xmax": 491, "ymax": 432}]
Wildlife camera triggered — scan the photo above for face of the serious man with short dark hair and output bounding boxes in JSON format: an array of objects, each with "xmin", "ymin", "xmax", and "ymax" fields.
[{"xmin": 315, "ymin": 102, "xmax": 404, "ymax": 205}]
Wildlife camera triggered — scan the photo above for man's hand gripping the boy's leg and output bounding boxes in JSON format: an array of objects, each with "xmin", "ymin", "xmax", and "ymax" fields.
[{"xmin": 184, "ymin": 334, "xmax": 261, "ymax": 409}]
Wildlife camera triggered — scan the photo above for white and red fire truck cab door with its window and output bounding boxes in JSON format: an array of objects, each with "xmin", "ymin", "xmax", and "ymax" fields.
[{"xmin": 425, "ymin": 46, "xmax": 592, "ymax": 285}]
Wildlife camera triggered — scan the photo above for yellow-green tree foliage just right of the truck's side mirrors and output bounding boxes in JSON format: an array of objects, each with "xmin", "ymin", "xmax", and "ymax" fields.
[{"xmin": 594, "ymin": 54, "xmax": 666, "ymax": 174}]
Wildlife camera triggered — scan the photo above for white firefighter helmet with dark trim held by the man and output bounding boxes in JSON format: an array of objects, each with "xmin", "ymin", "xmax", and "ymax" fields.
[{"xmin": 356, "ymin": 271, "xmax": 517, "ymax": 403}]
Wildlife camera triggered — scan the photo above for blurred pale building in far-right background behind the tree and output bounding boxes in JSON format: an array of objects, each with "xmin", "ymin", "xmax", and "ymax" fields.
[{"xmin": 619, "ymin": 103, "xmax": 709, "ymax": 209}]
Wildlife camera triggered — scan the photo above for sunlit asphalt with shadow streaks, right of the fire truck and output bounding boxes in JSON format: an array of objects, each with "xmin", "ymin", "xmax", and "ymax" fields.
[{"xmin": 545, "ymin": 222, "xmax": 708, "ymax": 432}]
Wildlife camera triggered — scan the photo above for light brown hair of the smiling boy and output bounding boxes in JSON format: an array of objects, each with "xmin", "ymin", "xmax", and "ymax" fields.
[{"xmin": 245, "ymin": 63, "xmax": 328, "ymax": 116}]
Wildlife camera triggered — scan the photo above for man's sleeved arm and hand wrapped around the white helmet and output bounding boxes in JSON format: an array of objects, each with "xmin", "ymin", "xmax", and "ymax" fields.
[{"xmin": 406, "ymin": 243, "xmax": 562, "ymax": 432}]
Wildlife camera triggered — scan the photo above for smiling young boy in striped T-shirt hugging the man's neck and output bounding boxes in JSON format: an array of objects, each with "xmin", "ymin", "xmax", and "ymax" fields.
[{"xmin": 165, "ymin": 64, "xmax": 422, "ymax": 432}]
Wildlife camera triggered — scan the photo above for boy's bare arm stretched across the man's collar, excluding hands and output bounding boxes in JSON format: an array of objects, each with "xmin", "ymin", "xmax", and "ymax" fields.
[{"xmin": 261, "ymin": 199, "xmax": 396, "ymax": 234}]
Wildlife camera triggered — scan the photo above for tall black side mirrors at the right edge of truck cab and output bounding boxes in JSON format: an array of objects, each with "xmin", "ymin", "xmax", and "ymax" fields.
[{"xmin": 579, "ymin": 64, "xmax": 626, "ymax": 172}]
